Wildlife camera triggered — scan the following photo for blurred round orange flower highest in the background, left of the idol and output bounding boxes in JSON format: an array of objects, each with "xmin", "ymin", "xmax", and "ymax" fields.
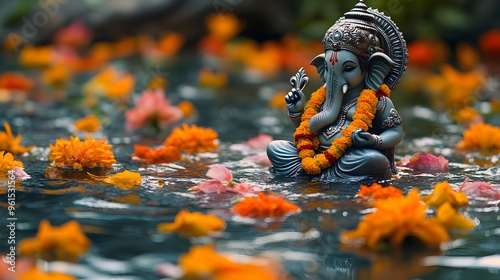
[{"xmin": 206, "ymin": 13, "xmax": 241, "ymax": 41}]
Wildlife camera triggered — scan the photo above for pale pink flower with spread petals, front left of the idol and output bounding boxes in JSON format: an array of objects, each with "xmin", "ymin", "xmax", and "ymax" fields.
[{"xmin": 189, "ymin": 164, "xmax": 257, "ymax": 194}]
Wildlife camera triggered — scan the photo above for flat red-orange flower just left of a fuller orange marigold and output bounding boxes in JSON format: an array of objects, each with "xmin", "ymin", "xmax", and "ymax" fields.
[{"xmin": 132, "ymin": 145, "xmax": 181, "ymax": 164}]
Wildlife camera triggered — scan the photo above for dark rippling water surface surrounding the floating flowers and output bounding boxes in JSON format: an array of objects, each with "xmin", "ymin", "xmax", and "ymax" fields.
[{"xmin": 0, "ymin": 53, "xmax": 500, "ymax": 280}]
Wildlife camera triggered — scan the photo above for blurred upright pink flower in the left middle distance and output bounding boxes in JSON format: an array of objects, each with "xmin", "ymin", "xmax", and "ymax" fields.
[{"xmin": 125, "ymin": 89, "xmax": 182, "ymax": 130}]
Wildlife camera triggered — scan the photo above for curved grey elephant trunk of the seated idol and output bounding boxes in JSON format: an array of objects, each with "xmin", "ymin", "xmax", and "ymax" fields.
[{"xmin": 309, "ymin": 68, "xmax": 348, "ymax": 135}]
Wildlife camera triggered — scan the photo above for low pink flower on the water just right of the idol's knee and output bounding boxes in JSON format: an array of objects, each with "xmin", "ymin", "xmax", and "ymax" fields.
[{"xmin": 397, "ymin": 152, "xmax": 448, "ymax": 173}]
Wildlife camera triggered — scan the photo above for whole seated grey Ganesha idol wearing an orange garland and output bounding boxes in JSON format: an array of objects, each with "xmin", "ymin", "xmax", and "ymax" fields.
[{"xmin": 267, "ymin": 1, "xmax": 408, "ymax": 182}]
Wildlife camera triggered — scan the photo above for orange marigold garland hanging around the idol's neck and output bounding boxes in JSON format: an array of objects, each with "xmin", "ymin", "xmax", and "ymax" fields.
[{"xmin": 293, "ymin": 84, "xmax": 391, "ymax": 175}]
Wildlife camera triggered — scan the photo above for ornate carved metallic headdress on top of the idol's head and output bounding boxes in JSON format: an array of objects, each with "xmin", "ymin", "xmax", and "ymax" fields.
[{"xmin": 323, "ymin": 0, "xmax": 408, "ymax": 89}]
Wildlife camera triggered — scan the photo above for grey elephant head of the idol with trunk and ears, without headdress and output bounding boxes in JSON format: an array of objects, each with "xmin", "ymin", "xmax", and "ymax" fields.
[{"xmin": 309, "ymin": 49, "xmax": 394, "ymax": 135}]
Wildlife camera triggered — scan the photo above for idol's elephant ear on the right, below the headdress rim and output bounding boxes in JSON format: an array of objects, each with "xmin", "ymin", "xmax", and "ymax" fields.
[{"xmin": 365, "ymin": 52, "xmax": 394, "ymax": 91}]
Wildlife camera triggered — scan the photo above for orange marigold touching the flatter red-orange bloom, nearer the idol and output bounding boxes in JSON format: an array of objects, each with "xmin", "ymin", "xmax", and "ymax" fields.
[{"xmin": 164, "ymin": 124, "xmax": 219, "ymax": 153}]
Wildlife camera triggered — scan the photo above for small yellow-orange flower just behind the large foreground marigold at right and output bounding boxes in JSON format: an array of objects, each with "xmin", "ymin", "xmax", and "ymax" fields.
[{"xmin": 421, "ymin": 181, "xmax": 469, "ymax": 208}]
